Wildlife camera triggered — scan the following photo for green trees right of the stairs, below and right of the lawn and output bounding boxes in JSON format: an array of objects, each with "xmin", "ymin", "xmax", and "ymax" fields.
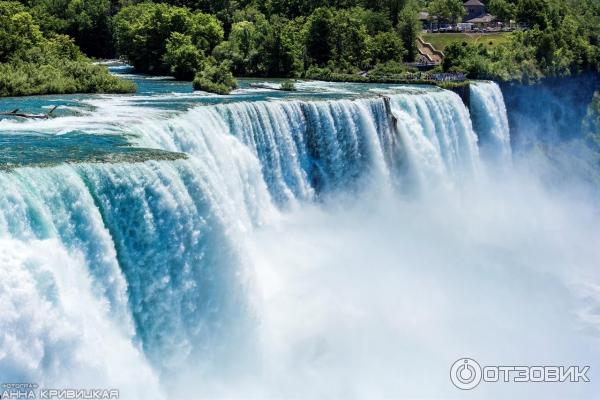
[{"xmin": 443, "ymin": 0, "xmax": 600, "ymax": 83}]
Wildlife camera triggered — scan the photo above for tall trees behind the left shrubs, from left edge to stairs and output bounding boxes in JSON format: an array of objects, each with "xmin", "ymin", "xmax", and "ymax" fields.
[{"xmin": 0, "ymin": 0, "xmax": 422, "ymax": 92}]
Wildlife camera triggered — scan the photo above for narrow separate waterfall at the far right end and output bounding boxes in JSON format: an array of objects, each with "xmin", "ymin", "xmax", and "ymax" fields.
[{"xmin": 470, "ymin": 82, "xmax": 511, "ymax": 165}]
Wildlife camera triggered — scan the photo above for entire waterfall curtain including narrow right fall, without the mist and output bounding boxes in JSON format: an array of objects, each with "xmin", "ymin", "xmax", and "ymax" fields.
[{"xmin": 0, "ymin": 83, "xmax": 544, "ymax": 399}]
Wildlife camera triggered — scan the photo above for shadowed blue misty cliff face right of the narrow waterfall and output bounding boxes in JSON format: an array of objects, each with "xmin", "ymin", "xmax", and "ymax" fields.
[{"xmin": 502, "ymin": 74, "xmax": 600, "ymax": 194}]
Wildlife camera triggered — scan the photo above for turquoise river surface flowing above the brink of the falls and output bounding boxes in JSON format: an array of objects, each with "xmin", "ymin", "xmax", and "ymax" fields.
[{"xmin": 0, "ymin": 65, "xmax": 432, "ymax": 170}]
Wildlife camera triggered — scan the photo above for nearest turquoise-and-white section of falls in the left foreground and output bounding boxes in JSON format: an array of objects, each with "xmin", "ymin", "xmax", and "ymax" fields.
[{"xmin": 0, "ymin": 161, "xmax": 264, "ymax": 398}]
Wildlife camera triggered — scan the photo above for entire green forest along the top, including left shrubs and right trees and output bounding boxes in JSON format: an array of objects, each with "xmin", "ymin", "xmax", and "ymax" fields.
[{"xmin": 0, "ymin": 0, "xmax": 600, "ymax": 95}]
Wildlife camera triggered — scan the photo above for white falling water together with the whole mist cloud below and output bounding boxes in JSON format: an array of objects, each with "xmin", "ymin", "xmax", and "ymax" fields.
[{"xmin": 0, "ymin": 82, "xmax": 600, "ymax": 399}]
